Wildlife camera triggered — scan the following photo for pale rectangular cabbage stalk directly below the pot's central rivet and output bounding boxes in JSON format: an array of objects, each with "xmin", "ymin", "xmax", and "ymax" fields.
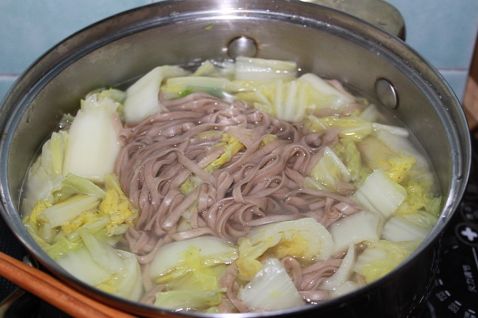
[{"xmin": 235, "ymin": 56, "xmax": 297, "ymax": 81}]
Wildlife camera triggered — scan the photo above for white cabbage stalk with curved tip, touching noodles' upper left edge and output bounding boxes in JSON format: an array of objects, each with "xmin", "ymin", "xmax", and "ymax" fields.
[{"xmin": 124, "ymin": 65, "xmax": 188, "ymax": 124}]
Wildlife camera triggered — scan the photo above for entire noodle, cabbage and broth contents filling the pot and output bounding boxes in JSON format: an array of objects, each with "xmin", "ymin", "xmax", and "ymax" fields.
[{"xmin": 22, "ymin": 57, "xmax": 441, "ymax": 313}]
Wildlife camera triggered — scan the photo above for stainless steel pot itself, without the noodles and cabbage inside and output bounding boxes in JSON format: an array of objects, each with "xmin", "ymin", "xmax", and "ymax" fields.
[{"xmin": 0, "ymin": 0, "xmax": 470, "ymax": 317}]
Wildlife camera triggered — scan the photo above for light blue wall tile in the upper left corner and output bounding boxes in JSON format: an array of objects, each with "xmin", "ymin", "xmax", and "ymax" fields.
[{"xmin": 0, "ymin": 0, "xmax": 150, "ymax": 74}]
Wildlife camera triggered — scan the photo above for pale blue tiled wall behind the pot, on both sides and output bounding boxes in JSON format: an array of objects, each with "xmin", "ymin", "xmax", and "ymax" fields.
[{"xmin": 0, "ymin": 0, "xmax": 478, "ymax": 98}]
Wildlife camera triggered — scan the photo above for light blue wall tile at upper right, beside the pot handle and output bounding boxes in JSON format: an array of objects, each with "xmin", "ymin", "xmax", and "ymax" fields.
[{"xmin": 388, "ymin": 0, "xmax": 478, "ymax": 69}]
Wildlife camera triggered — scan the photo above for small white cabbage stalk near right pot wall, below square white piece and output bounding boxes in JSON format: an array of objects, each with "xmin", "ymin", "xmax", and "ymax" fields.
[{"xmin": 382, "ymin": 216, "xmax": 429, "ymax": 242}]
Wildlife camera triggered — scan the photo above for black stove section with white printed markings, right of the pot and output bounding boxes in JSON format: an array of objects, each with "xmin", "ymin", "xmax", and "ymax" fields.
[{"xmin": 423, "ymin": 139, "xmax": 478, "ymax": 318}]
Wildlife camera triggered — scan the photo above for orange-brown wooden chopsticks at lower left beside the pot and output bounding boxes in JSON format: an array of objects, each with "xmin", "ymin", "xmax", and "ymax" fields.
[{"xmin": 0, "ymin": 252, "xmax": 134, "ymax": 318}]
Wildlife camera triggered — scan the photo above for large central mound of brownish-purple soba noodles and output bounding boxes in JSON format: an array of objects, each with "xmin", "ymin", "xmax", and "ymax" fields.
[{"xmin": 115, "ymin": 93, "xmax": 359, "ymax": 255}]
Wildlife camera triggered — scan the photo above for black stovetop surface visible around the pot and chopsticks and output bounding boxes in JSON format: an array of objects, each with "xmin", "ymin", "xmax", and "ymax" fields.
[{"xmin": 0, "ymin": 135, "xmax": 478, "ymax": 318}]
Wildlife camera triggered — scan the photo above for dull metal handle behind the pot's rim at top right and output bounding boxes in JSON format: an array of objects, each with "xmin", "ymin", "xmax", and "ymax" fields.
[{"xmin": 301, "ymin": 0, "xmax": 405, "ymax": 40}]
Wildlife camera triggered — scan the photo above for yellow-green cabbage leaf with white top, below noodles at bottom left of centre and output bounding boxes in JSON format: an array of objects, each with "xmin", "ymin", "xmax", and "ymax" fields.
[{"xmin": 149, "ymin": 236, "xmax": 237, "ymax": 310}]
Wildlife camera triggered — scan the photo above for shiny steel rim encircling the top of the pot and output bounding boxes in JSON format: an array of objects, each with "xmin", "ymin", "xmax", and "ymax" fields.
[{"xmin": 0, "ymin": 0, "xmax": 471, "ymax": 317}]
